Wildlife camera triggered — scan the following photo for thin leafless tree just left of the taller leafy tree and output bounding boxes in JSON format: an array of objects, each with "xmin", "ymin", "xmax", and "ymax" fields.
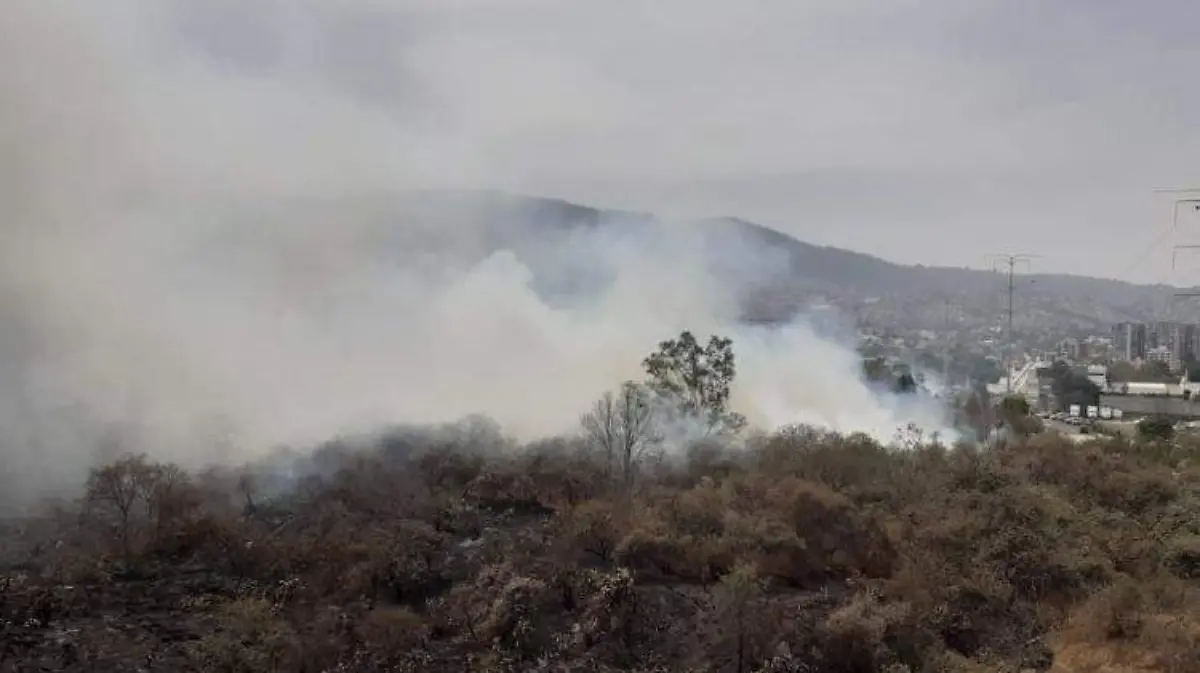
[{"xmin": 580, "ymin": 381, "xmax": 656, "ymax": 486}]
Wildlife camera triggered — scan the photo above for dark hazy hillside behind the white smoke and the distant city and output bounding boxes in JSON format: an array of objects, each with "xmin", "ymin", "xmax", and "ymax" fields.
[{"xmin": 391, "ymin": 192, "xmax": 1196, "ymax": 330}]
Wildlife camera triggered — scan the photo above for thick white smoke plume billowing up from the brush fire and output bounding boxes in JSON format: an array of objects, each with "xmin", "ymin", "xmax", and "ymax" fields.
[{"xmin": 0, "ymin": 0, "xmax": 942, "ymax": 508}]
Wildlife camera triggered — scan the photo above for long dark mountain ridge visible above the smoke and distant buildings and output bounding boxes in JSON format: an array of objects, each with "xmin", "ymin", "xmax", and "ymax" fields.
[{"xmin": 398, "ymin": 191, "xmax": 1185, "ymax": 332}]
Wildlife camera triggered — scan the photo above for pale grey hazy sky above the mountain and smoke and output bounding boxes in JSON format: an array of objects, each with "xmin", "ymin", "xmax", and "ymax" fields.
[{"xmin": 54, "ymin": 0, "xmax": 1200, "ymax": 282}]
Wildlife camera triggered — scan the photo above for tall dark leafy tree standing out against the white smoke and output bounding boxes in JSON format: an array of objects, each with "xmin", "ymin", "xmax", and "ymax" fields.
[{"xmin": 642, "ymin": 330, "xmax": 745, "ymax": 429}]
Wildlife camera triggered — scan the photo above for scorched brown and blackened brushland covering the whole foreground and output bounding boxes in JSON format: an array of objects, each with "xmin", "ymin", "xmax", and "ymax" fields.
[{"xmin": 0, "ymin": 339, "xmax": 1200, "ymax": 673}]
